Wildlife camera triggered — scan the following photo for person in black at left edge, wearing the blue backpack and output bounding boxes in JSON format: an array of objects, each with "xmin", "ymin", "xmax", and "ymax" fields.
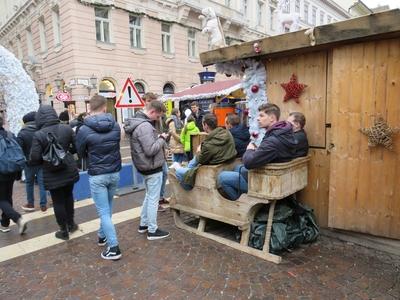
[{"xmin": 0, "ymin": 117, "xmax": 26, "ymax": 234}]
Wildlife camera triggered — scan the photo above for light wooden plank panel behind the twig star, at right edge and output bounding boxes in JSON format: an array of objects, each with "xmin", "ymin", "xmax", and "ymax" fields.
[{"xmin": 329, "ymin": 38, "xmax": 400, "ymax": 239}]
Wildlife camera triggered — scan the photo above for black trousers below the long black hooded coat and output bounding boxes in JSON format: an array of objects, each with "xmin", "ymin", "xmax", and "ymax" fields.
[{"xmin": 50, "ymin": 184, "xmax": 74, "ymax": 227}]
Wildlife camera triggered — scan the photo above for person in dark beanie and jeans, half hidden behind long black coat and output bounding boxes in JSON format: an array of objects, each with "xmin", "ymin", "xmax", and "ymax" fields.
[{"xmin": 17, "ymin": 111, "xmax": 47, "ymax": 212}]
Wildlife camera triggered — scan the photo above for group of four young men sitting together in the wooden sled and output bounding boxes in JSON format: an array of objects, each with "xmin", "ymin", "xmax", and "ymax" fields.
[{"xmin": 173, "ymin": 103, "xmax": 308, "ymax": 200}]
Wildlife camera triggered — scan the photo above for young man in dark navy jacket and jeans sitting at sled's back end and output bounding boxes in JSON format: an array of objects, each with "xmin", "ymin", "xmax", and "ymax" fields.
[{"xmin": 218, "ymin": 103, "xmax": 296, "ymax": 200}]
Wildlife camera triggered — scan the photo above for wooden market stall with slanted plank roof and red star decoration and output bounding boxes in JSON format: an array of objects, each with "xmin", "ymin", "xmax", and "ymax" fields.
[{"xmin": 200, "ymin": 9, "xmax": 400, "ymax": 239}]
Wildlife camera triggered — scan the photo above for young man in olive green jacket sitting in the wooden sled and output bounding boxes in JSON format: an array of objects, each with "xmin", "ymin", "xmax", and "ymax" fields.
[{"xmin": 176, "ymin": 114, "xmax": 236, "ymax": 190}]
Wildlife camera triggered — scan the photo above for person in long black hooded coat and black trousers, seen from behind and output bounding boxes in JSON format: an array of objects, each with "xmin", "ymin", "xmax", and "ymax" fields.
[{"xmin": 30, "ymin": 105, "xmax": 79, "ymax": 240}]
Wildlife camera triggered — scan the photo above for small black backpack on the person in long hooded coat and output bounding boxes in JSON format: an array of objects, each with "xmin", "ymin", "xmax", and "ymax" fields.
[{"xmin": 42, "ymin": 132, "xmax": 67, "ymax": 171}]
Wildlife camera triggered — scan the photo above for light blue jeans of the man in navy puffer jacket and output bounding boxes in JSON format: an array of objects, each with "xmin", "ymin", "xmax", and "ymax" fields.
[{"xmin": 89, "ymin": 172, "xmax": 119, "ymax": 247}]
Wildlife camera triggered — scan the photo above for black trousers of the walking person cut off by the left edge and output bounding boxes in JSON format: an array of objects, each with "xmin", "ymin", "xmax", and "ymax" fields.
[{"xmin": 0, "ymin": 179, "xmax": 21, "ymax": 227}]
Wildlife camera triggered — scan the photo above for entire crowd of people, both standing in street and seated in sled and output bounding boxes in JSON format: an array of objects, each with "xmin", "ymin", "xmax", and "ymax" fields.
[{"xmin": 0, "ymin": 93, "xmax": 308, "ymax": 260}]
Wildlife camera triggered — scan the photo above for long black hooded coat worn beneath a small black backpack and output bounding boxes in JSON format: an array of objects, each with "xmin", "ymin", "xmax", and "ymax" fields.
[{"xmin": 30, "ymin": 105, "xmax": 79, "ymax": 190}]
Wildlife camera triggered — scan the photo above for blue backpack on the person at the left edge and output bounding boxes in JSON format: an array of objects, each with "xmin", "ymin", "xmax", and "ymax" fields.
[{"xmin": 0, "ymin": 132, "xmax": 26, "ymax": 174}]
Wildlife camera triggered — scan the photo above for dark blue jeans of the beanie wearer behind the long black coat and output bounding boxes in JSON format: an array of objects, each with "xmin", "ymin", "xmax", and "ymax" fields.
[{"xmin": 25, "ymin": 166, "xmax": 47, "ymax": 206}]
